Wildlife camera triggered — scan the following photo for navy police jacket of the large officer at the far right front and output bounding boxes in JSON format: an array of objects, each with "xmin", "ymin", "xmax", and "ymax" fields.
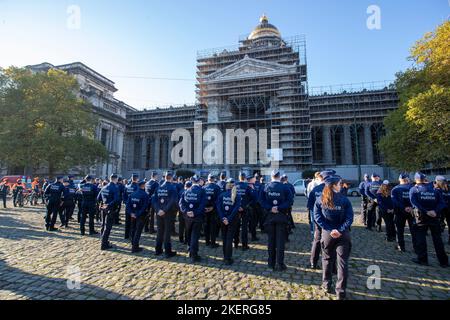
[{"xmin": 409, "ymin": 184, "xmax": 445, "ymax": 224}]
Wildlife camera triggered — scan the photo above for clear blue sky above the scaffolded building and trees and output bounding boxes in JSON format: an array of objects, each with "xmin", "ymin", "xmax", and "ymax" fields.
[{"xmin": 0, "ymin": 0, "xmax": 450, "ymax": 109}]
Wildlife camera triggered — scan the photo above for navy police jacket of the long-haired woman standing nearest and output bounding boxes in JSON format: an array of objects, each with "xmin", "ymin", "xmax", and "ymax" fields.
[{"xmin": 314, "ymin": 193, "xmax": 353, "ymax": 233}]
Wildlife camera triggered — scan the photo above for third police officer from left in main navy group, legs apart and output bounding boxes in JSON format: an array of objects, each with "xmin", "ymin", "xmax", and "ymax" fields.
[{"xmin": 80, "ymin": 175, "xmax": 98, "ymax": 236}]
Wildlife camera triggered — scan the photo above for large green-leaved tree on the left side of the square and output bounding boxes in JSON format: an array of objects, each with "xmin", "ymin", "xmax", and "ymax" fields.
[{"xmin": 0, "ymin": 67, "xmax": 108, "ymax": 176}]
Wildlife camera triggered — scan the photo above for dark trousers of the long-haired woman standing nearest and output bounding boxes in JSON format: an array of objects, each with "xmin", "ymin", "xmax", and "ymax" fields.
[{"xmin": 321, "ymin": 230, "xmax": 352, "ymax": 294}]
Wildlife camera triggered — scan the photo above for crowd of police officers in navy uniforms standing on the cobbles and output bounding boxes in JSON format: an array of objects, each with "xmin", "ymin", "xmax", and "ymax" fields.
[{"xmin": 0, "ymin": 170, "xmax": 450, "ymax": 299}]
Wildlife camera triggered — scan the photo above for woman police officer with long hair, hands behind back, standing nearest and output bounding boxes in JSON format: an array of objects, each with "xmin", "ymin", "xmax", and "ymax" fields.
[{"xmin": 314, "ymin": 176, "xmax": 353, "ymax": 300}]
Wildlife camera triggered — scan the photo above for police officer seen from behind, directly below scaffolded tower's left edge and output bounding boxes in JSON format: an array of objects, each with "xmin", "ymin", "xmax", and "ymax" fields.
[{"xmin": 179, "ymin": 175, "xmax": 206, "ymax": 263}]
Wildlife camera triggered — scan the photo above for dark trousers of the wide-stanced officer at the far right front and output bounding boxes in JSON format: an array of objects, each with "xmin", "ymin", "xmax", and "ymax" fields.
[{"xmin": 415, "ymin": 219, "xmax": 448, "ymax": 265}]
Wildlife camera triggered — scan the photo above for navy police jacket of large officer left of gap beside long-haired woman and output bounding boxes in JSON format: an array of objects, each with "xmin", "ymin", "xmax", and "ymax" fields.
[{"xmin": 261, "ymin": 181, "xmax": 294, "ymax": 212}]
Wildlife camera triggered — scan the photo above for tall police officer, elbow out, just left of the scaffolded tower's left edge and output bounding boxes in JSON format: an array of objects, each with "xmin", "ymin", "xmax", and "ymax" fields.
[{"xmin": 152, "ymin": 171, "xmax": 178, "ymax": 258}]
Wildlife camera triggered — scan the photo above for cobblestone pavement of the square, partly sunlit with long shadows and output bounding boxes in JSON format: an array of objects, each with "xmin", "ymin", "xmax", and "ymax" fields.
[{"xmin": 0, "ymin": 199, "xmax": 450, "ymax": 300}]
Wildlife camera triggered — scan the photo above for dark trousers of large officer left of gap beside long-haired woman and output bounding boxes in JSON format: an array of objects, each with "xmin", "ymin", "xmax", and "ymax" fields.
[{"xmin": 264, "ymin": 212, "xmax": 289, "ymax": 267}]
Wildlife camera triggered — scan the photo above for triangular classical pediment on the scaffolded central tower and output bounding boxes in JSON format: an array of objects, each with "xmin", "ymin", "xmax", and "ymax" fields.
[{"xmin": 204, "ymin": 56, "xmax": 296, "ymax": 82}]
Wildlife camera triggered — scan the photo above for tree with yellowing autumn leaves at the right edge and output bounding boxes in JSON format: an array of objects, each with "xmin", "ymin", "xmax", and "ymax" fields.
[{"xmin": 380, "ymin": 21, "xmax": 450, "ymax": 171}]
